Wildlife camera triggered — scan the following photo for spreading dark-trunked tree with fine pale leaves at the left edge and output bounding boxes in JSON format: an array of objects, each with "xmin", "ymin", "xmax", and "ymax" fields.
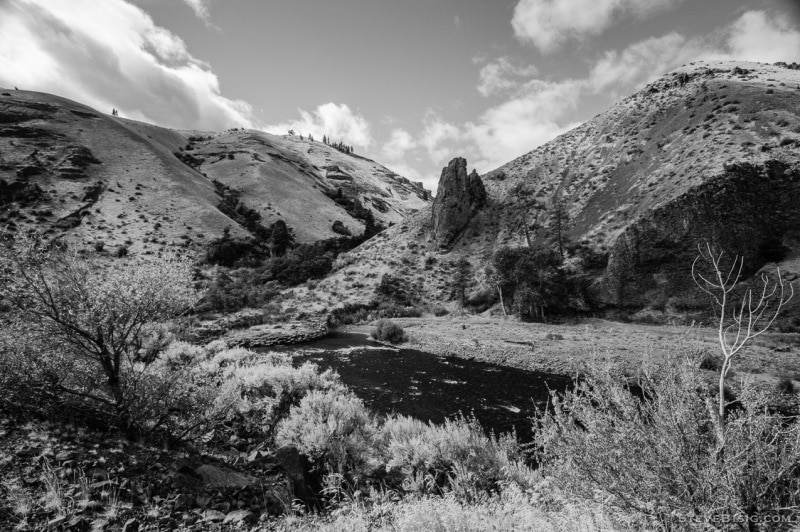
[{"xmin": 0, "ymin": 236, "xmax": 197, "ymax": 432}]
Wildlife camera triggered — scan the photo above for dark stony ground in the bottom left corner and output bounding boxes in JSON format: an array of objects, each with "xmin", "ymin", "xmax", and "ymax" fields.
[{"xmin": 0, "ymin": 416, "xmax": 318, "ymax": 532}]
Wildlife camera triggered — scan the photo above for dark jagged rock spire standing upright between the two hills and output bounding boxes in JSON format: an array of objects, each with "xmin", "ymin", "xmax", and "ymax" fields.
[{"xmin": 433, "ymin": 157, "xmax": 486, "ymax": 248}]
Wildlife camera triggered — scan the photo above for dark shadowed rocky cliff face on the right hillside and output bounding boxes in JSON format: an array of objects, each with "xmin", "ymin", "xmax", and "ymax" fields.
[{"xmin": 594, "ymin": 160, "xmax": 800, "ymax": 308}]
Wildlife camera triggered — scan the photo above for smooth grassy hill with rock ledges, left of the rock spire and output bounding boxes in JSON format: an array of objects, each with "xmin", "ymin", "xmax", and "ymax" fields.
[{"xmin": 0, "ymin": 89, "xmax": 430, "ymax": 254}]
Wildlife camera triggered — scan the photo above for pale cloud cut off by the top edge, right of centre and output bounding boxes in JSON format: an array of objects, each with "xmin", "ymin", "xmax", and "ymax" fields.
[{"xmin": 511, "ymin": 0, "xmax": 683, "ymax": 53}]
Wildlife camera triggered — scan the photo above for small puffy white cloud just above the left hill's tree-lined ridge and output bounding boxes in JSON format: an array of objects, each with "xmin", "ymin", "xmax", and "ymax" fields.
[{"xmin": 265, "ymin": 102, "xmax": 373, "ymax": 148}]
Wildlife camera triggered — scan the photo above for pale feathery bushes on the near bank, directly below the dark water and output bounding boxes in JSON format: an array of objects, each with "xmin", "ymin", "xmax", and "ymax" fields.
[{"xmin": 276, "ymin": 390, "xmax": 535, "ymax": 500}]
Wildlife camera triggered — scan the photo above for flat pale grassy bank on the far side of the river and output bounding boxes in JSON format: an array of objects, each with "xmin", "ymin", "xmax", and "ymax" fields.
[{"xmin": 354, "ymin": 316, "xmax": 800, "ymax": 384}]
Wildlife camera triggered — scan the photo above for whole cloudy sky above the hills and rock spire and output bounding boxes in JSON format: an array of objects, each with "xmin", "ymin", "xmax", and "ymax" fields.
[{"xmin": 0, "ymin": 0, "xmax": 800, "ymax": 191}]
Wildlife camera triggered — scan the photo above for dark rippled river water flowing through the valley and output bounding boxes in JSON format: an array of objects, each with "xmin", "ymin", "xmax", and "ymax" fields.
[{"xmin": 272, "ymin": 332, "xmax": 572, "ymax": 441}]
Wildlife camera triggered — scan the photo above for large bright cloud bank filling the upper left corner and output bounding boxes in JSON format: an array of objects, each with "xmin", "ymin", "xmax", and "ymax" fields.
[{"xmin": 0, "ymin": 0, "xmax": 253, "ymax": 130}]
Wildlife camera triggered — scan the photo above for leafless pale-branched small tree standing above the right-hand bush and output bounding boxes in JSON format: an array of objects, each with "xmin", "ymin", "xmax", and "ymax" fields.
[{"xmin": 692, "ymin": 243, "xmax": 794, "ymax": 448}]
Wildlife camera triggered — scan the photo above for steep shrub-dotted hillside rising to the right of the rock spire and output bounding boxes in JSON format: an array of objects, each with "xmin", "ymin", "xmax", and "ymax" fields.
[{"xmin": 284, "ymin": 62, "xmax": 800, "ymax": 318}]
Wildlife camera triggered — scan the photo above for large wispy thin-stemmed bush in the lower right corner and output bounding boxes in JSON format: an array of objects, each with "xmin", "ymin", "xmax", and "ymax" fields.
[{"xmin": 536, "ymin": 360, "xmax": 800, "ymax": 530}]
